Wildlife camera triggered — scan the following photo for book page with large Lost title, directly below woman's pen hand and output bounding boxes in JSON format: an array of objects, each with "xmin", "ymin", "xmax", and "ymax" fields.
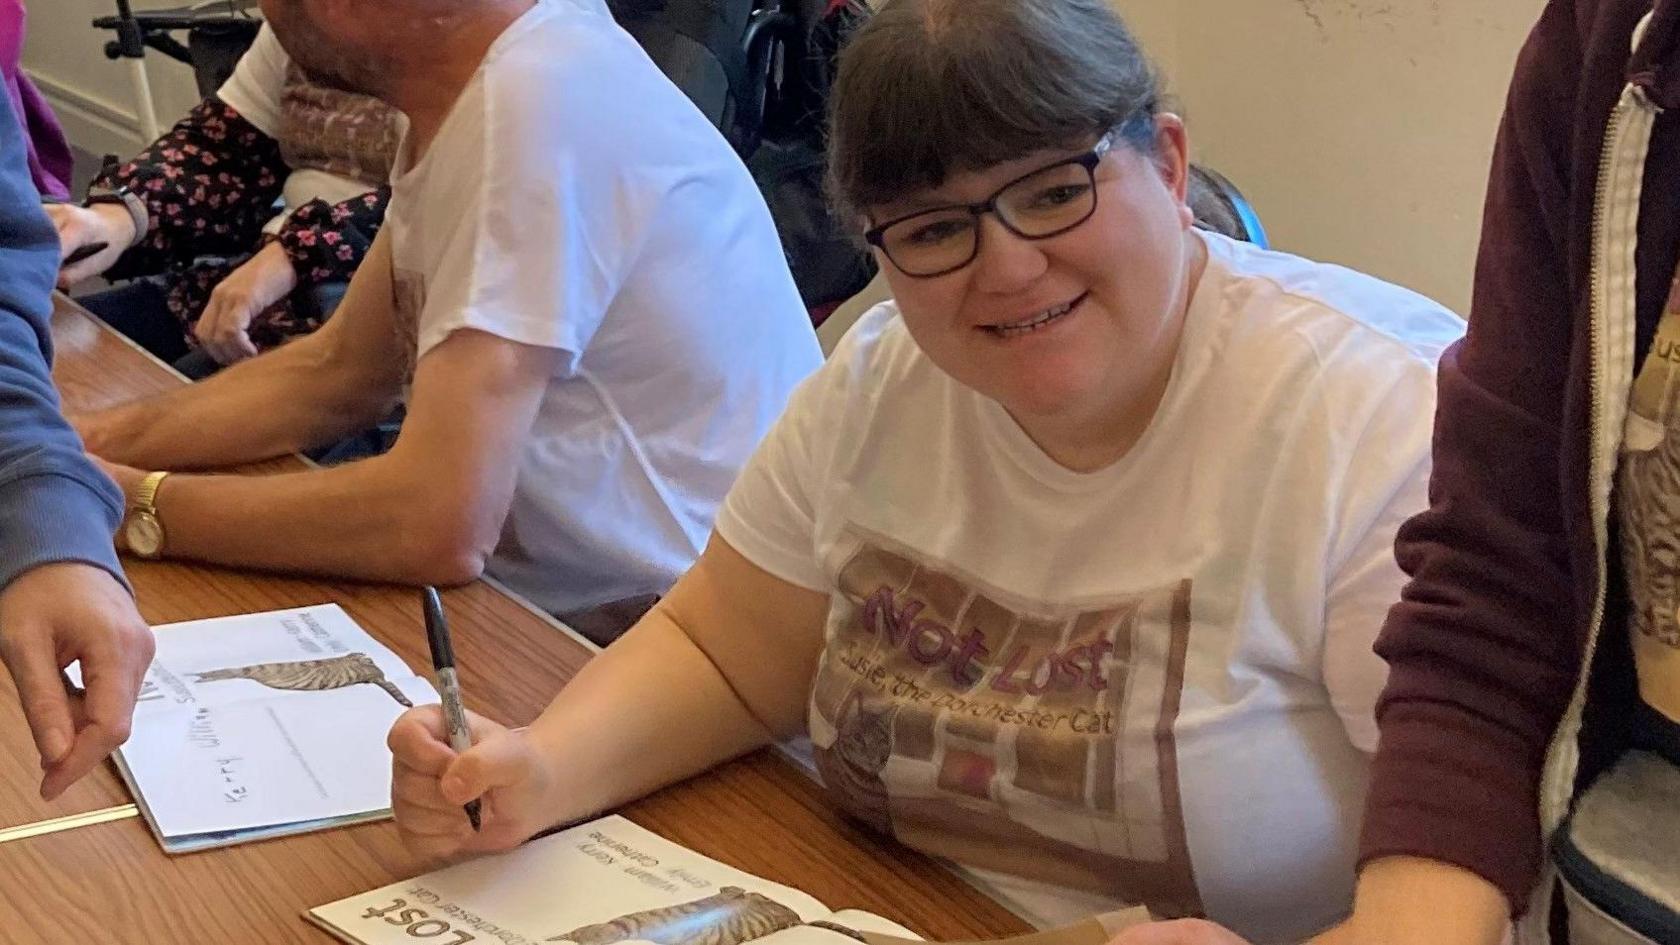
[{"xmin": 309, "ymin": 816, "xmax": 909, "ymax": 945}]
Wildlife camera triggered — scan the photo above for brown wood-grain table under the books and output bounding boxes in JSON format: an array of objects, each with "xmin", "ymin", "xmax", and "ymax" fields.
[{"xmin": 0, "ymin": 299, "xmax": 1025, "ymax": 945}]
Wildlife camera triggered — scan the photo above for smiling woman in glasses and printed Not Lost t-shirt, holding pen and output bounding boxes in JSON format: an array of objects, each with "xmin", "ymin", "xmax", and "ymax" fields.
[{"xmin": 393, "ymin": 0, "xmax": 1462, "ymax": 943}]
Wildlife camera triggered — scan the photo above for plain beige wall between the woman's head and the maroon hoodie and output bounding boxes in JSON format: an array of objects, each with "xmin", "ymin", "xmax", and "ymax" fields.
[{"xmin": 1116, "ymin": 0, "xmax": 1544, "ymax": 313}]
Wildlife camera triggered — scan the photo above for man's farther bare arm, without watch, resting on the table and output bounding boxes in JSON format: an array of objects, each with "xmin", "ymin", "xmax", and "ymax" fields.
[{"xmin": 72, "ymin": 232, "xmax": 412, "ymax": 469}]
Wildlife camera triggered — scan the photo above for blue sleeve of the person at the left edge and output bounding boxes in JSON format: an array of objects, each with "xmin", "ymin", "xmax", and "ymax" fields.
[{"xmin": 0, "ymin": 89, "xmax": 123, "ymax": 587}]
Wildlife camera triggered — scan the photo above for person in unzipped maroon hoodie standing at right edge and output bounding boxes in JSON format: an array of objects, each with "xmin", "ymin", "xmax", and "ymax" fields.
[{"xmin": 1119, "ymin": 0, "xmax": 1680, "ymax": 945}]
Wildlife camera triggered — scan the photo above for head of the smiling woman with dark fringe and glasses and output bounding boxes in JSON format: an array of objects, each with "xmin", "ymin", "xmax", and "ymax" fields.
[{"xmin": 832, "ymin": 3, "xmax": 1206, "ymax": 471}]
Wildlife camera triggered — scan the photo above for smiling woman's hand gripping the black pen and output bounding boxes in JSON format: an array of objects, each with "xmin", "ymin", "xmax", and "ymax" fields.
[{"xmin": 386, "ymin": 705, "xmax": 558, "ymax": 859}]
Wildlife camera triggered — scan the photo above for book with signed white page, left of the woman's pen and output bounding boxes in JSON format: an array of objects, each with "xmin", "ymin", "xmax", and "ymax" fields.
[{"xmin": 71, "ymin": 604, "xmax": 438, "ymax": 853}]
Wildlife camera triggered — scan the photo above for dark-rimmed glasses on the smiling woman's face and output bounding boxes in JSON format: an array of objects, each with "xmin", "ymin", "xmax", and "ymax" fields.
[{"xmin": 864, "ymin": 131, "xmax": 1117, "ymax": 279}]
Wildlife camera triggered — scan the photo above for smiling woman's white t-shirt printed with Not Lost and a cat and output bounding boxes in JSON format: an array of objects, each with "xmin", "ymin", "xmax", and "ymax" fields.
[{"xmin": 717, "ymin": 235, "xmax": 1463, "ymax": 943}]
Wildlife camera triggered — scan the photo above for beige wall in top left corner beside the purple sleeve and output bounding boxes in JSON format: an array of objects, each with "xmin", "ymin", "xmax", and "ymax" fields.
[{"xmin": 24, "ymin": 0, "xmax": 198, "ymax": 155}]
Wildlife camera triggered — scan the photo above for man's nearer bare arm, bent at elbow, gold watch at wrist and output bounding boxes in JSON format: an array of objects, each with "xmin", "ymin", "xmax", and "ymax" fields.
[{"xmin": 101, "ymin": 330, "xmax": 559, "ymax": 583}]
